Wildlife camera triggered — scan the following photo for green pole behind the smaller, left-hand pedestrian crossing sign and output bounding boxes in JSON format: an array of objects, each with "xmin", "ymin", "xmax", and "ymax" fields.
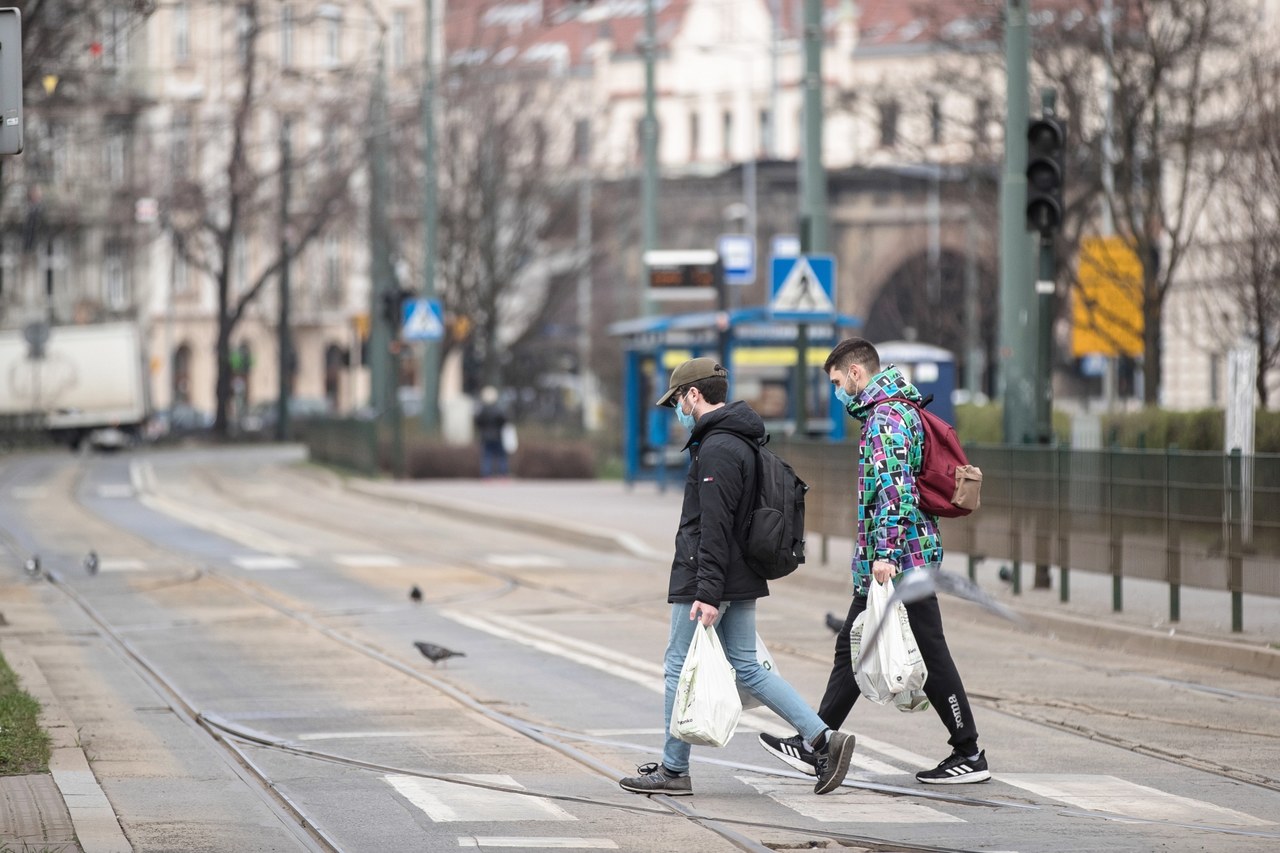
[{"xmin": 421, "ymin": 0, "xmax": 440, "ymax": 434}]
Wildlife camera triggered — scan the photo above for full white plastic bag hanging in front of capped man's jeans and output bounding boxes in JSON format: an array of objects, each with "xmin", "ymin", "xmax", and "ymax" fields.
[{"xmin": 671, "ymin": 625, "xmax": 742, "ymax": 747}]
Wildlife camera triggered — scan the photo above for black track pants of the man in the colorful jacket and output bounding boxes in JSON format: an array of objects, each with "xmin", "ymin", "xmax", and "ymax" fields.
[{"xmin": 818, "ymin": 596, "xmax": 978, "ymax": 756}]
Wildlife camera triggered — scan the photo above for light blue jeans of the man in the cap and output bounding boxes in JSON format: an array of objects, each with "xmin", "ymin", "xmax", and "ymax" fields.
[{"xmin": 662, "ymin": 601, "xmax": 827, "ymax": 774}]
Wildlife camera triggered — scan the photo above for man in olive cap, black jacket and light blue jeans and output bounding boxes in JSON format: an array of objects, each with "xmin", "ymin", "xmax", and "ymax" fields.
[{"xmin": 620, "ymin": 359, "xmax": 854, "ymax": 795}]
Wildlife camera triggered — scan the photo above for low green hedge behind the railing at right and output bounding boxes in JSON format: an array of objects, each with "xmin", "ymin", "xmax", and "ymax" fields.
[{"xmin": 956, "ymin": 403, "xmax": 1280, "ymax": 453}]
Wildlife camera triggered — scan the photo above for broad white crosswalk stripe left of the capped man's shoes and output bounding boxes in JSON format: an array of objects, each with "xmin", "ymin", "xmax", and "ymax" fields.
[{"xmin": 383, "ymin": 774, "xmax": 577, "ymax": 824}]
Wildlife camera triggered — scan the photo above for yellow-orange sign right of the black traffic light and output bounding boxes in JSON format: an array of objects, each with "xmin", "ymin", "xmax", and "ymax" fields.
[{"xmin": 1071, "ymin": 237, "xmax": 1143, "ymax": 357}]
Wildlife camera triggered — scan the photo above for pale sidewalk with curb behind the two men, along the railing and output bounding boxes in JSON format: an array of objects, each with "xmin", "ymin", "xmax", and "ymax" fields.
[{"xmin": 346, "ymin": 479, "xmax": 1280, "ymax": 678}]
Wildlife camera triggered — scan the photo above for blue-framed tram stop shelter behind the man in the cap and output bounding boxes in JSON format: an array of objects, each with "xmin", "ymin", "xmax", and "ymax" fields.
[{"xmin": 609, "ymin": 307, "xmax": 861, "ymax": 488}]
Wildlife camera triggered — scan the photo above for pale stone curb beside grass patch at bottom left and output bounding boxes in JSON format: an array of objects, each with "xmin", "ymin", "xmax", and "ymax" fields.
[{"xmin": 0, "ymin": 639, "xmax": 133, "ymax": 853}]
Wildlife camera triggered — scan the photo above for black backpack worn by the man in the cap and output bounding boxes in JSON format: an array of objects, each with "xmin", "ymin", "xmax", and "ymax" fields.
[{"xmin": 717, "ymin": 430, "xmax": 809, "ymax": 580}]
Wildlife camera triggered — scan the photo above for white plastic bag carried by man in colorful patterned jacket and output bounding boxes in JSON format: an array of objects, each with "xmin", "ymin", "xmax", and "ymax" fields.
[{"xmin": 849, "ymin": 581, "xmax": 929, "ymax": 711}]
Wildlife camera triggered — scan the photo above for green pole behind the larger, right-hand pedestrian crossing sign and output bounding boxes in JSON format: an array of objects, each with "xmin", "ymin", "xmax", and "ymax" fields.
[{"xmin": 795, "ymin": 0, "xmax": 828, "ymax": 437}]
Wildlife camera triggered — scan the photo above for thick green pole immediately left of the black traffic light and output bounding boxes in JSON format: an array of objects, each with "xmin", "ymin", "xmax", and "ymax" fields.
[{"xmin": 1000, "ymin": 0, "xmax": 1038, "ymax": 444}]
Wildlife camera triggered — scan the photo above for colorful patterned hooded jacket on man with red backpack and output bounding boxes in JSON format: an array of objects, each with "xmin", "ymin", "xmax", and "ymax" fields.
[{"xmin": 849, "ymin": 365, "xmax": 942, "ymax": 596}]
